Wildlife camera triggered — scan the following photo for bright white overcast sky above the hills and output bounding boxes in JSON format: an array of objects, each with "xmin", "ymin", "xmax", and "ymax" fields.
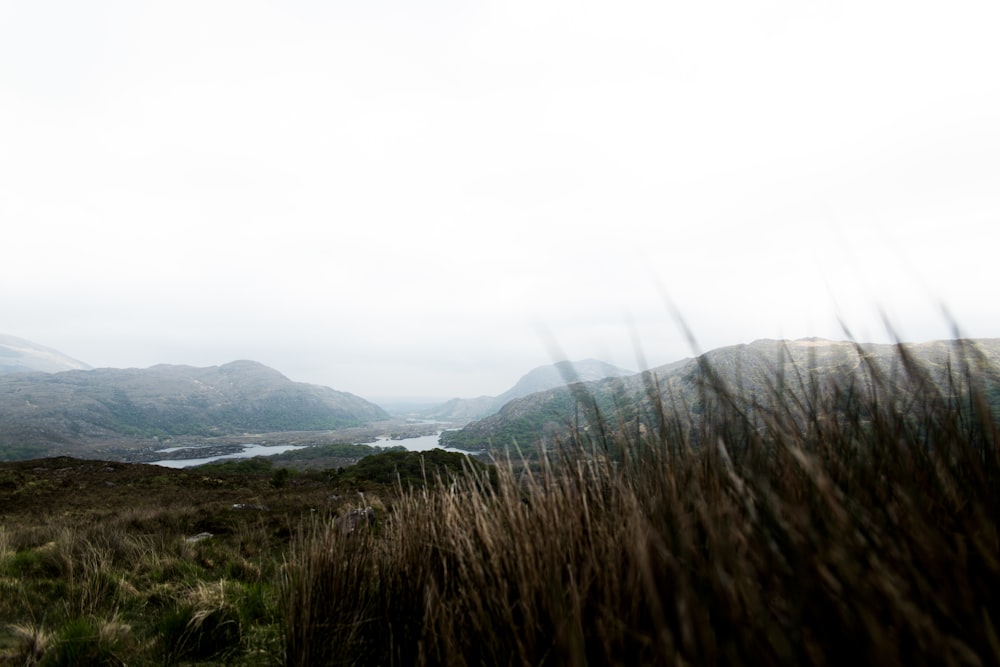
[{"xmin": 0, "ymin": 0, "xmax": 1000, "ymax": 397}]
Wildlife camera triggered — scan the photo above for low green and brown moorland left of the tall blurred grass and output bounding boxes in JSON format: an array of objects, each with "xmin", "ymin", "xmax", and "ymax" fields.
[{"xmin": 0, "ymin": 451, "xmax": 476, "ymax": 665}]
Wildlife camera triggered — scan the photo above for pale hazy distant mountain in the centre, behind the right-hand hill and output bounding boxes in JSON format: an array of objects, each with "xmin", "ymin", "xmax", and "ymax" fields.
[{"xmin": 421, "ymin": 359, "xmax": 633, "ymax": 424}]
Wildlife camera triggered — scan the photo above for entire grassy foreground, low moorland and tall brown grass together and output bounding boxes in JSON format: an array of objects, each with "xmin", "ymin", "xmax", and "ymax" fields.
[{"xmin": 0, "ymin": 348, "xmax": 1000, "ymax": 665}]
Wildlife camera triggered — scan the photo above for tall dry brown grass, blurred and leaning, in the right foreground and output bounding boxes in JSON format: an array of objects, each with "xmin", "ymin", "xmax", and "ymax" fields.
[{"xmin": 282, "ymin": 346, "xmax": 1000, "ymax": 665}]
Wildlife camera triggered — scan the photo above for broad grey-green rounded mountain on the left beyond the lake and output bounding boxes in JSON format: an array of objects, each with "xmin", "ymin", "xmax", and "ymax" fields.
[{"xmin": 0, "ymin": 361, "xmax": 388, "ymax": 458}]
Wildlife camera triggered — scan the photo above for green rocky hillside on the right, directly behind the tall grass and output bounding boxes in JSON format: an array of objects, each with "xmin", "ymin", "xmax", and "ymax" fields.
[{"xmin": 441, "ymin": 338, "xmax": 1000, "ymax": 450}]
